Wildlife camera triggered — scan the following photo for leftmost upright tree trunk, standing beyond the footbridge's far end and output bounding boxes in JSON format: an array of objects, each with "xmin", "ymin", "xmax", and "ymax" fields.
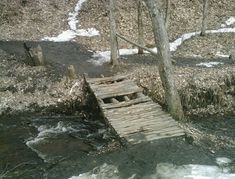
[{"xmin": 109, "ymin": 0, "xmax": 119, "ymax": 66}]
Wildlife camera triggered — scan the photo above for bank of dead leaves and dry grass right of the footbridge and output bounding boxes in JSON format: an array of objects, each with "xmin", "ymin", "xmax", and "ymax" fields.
[{"xmin": 127, "ymin": 66, "xmax": 235, "ymax": 116}]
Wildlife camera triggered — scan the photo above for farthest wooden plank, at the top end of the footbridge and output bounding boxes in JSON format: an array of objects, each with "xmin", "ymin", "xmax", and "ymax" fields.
[{"xmin": 86, "ymin": 75, "xmax": 128, "ymax": 84}]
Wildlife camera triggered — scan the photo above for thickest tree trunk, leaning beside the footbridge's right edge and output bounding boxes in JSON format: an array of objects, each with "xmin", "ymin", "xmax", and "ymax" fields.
[{"xmin": 145, "ymin": 0, "xmax": 184, "ymax": 119}]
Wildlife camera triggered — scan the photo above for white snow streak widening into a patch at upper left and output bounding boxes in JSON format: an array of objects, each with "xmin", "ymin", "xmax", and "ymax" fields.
[{"xmin": 42, "ymin": 0, "xmax": 100, "ymax": 42}]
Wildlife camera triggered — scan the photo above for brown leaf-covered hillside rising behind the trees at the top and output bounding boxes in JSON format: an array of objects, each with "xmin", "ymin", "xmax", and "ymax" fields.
[{"xmin": 0, "ymin": 0, "xmax": 235, "ymax": 56}]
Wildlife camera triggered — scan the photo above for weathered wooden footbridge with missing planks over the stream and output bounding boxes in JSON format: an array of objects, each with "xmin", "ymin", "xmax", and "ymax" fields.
[{"xmin": 85, "ymin": 76, "xmax": 184, "ymax": 144}]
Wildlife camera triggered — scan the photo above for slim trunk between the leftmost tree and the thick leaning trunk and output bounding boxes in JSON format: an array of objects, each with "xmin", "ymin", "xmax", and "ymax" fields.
[{"xmin": 137, "ymin": 0, "xmax": 144, "ymax": 54}]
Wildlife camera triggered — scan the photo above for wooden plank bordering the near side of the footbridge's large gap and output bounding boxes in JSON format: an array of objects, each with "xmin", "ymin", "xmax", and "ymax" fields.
[{"xmin": 101, "ymin": 96, "xmax": 151, "ymax": 109}]
